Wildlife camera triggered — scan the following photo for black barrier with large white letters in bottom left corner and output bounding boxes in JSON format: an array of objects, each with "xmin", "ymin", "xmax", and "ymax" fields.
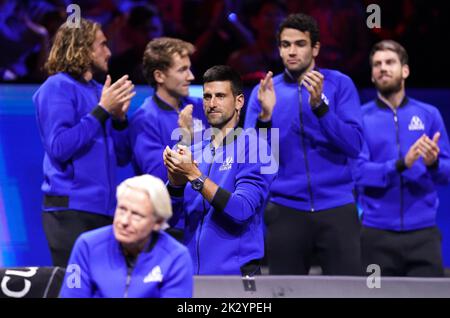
[{"xmin": 0, "ymin": 267, "xmax": 65, "ymax": 298}]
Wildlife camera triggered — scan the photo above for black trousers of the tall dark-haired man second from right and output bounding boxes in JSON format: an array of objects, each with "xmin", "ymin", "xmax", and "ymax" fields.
[{"xmin": 265, "ymin": 203, "xmax": 362, "ymax": 275}]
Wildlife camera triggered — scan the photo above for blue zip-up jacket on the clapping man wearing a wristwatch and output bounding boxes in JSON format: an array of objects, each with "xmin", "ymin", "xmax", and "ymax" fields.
[{"xmin": 168, "ymin": 129, "xmax": 278, "ymax": 275}]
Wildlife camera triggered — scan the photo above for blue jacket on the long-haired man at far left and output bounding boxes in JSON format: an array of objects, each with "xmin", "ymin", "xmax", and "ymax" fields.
[{"xmin": 33, "ymin": 73, "xmax": 130, "ymax": 216}]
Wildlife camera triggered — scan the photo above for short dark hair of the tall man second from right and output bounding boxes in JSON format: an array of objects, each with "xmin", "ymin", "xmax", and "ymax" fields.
[{"xmin": 277, "ymin": 13, "xmax": 320, "ymax": 46}]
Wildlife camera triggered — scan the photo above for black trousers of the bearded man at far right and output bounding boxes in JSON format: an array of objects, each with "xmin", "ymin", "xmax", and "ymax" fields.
[{"xmin": 361, "ymin": 226, "xmax": 444, "ymax": 277}]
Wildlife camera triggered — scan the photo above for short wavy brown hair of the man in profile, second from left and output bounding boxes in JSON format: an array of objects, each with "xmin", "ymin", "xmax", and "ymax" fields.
[{"xmin": 142, "ymin": 37, "xmax": 195, "ymax": 87}]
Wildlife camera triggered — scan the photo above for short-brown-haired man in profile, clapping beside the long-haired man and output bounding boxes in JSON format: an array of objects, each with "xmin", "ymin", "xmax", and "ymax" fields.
[{"xmin": 130, "ymin": 37, "xmax": 207, "ymax": 240}]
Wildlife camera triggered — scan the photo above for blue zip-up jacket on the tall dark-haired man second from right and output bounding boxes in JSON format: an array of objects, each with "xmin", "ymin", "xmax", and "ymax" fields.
[{"xmin": 245, "ymin": 69, "xmax": 363, "ymax": 211}]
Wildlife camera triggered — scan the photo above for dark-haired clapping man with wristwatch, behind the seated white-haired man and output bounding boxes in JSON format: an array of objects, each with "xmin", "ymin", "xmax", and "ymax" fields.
[{"xmin": 164, "ymin": 65, "xmax": 277, "ymax": 276}]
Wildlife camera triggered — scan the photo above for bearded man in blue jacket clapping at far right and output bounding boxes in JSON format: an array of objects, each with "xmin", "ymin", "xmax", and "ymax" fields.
[{"xmin": 355, "ymin": 40, "xmax": 450, "ymax": 277}]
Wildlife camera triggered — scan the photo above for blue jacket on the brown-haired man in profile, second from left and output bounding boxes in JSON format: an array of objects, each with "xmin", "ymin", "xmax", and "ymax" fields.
[{"xmin": 129, "ymin": 93, "xmax": 209, "ymax": 182}]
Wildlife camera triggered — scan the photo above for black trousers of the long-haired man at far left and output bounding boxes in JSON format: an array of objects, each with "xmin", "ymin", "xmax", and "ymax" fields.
[{"xmin": 42, "ymin": 210, "xmax": 113, "ymax": 267}]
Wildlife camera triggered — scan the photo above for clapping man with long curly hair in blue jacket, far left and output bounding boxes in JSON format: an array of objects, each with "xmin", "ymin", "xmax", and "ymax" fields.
[{"xmin": 33, "ymin": 19, "xmax": 134, "ymax": 267}]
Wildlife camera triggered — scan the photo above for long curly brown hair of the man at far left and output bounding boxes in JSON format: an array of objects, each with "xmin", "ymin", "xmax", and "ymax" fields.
[{"xmin": 45, "ymin": 19, "xmax": 101, "ymax": 78}]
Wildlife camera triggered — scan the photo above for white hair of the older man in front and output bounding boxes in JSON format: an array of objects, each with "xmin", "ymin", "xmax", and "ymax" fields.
[{"xmin": 116, "ymin": 174, "xmax": 172, "ymax": 221}]
